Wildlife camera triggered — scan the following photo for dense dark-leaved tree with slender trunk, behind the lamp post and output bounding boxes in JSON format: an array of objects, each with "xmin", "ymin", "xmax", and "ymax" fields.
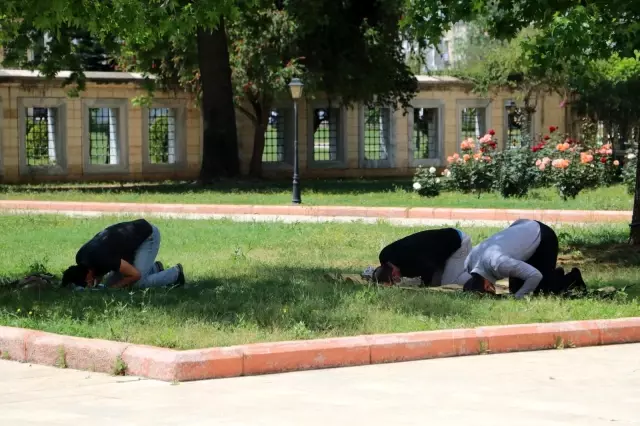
[{"xmin": 119, "ymin": 0, "xmax": 476, "ymax": 177}]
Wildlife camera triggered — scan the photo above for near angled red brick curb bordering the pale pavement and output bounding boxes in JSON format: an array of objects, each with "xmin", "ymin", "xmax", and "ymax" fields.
[{"xmin": 0, "ymin": 317, "xmax": 640, "ymax": 381}]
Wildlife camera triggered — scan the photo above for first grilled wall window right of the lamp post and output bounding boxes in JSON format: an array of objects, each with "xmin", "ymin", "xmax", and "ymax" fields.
[{"xmin": 313, "ymin": 108, "xmax": 341, "ymax": 161}]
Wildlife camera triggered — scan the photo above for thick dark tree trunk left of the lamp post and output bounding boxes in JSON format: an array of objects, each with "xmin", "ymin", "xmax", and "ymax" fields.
[{"xmin": 198, "ymin": 18, "xmax": 240, "ymax": 183}]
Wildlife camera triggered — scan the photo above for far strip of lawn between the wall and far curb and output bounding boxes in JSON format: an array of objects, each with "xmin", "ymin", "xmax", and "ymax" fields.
[{"xmin": 0, "ymin": 179, "xmax": 633, "ymax": 210}]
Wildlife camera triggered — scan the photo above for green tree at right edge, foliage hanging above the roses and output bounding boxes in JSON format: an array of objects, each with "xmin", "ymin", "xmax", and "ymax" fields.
[{"xmin": 475, "ymin": 0, "xmax": 640, "ymax": 245}]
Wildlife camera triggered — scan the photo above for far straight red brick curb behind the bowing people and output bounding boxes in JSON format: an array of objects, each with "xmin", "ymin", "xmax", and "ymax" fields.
[{"xmin": 0, "ymin": 200, "xmax": 631, "ymax": 223}]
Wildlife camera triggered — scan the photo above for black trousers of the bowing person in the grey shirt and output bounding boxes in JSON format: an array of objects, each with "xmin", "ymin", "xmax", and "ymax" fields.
[{"xmin": 509, "ymin": 222, "xmax": 564, "ymax": 294}]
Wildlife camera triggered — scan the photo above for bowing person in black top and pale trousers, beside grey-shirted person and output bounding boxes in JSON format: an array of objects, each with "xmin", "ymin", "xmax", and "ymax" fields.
[{"xmin": 373, "ymin": 228, "xmax": 471, "ymax": 286}]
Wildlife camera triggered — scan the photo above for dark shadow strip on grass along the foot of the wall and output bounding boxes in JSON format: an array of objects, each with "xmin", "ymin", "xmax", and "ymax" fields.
[{"xmin": 0, "ymin": 179, "xmax": 411, "ymax": 195}]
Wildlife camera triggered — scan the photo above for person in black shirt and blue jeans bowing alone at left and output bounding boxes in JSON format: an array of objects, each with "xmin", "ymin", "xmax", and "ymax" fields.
[{"xmin": 62, "ymin": 219, "xmax": 184, "ymax": 288}]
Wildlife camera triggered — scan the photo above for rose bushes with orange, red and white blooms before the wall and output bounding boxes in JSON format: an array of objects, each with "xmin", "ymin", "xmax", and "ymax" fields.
[{"xmin": 413, "ymin": 126, "xmax": 624, "ymax": 200}]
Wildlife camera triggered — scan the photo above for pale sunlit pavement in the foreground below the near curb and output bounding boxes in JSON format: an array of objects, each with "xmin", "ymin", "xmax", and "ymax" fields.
[{"xmin": 0, "ymin": 344, "xmax": 640, "ymax": 426}]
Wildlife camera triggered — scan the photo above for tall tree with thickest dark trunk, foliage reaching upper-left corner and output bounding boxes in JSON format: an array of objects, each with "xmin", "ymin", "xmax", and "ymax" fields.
[{"xmin": 0, "ymin": 0, "xmax": 240, "ymax": 181}]
